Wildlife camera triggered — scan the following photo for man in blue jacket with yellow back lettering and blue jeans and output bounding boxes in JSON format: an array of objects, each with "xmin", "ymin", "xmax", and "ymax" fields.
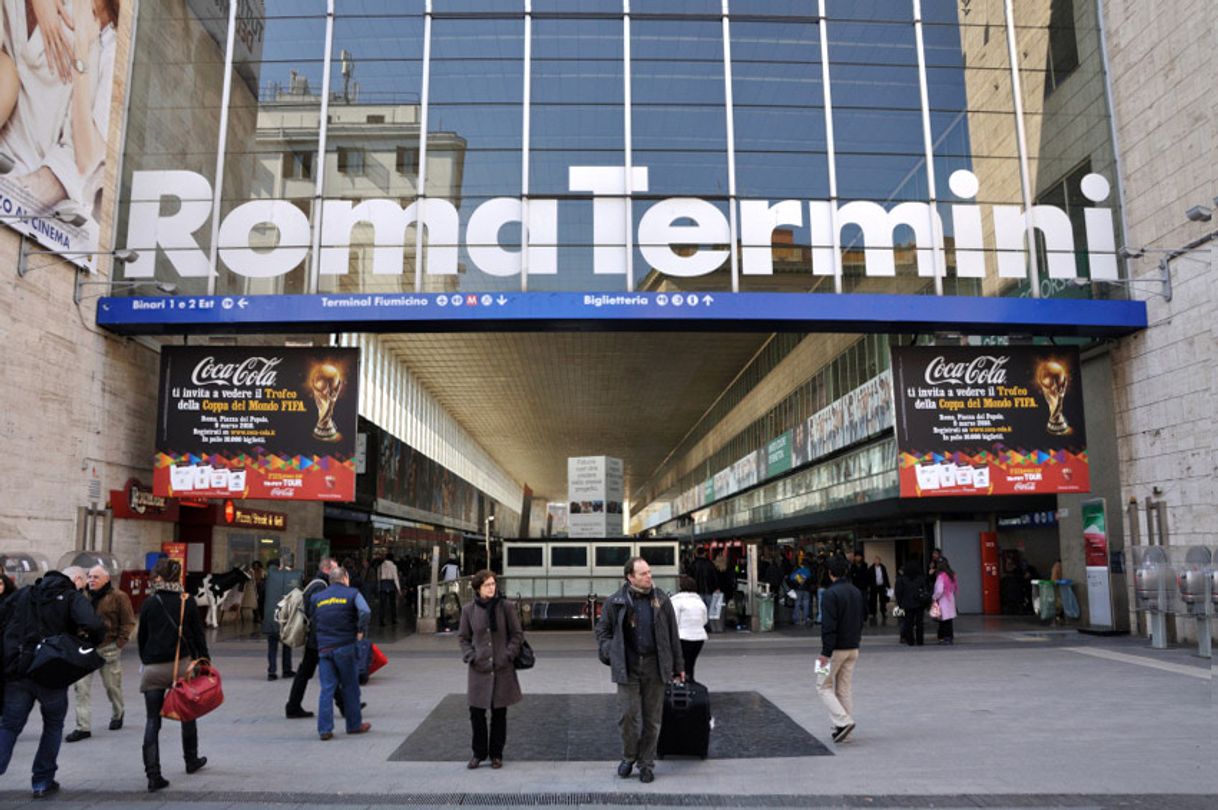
[{"xmin": 308, "ymin": 568, "xmax": 373, "ymax": 739}]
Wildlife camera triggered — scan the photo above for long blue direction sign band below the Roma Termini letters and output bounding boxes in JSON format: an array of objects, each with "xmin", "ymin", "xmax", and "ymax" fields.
[{"xmin": 90, "ymin": 292, "xmax": 1146, "ymax": 337}]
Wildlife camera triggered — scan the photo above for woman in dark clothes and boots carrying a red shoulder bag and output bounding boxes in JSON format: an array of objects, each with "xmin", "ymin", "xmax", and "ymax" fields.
[{"xmin": 136, "ymin": 558, "xmax": 211, "ymax": 793}]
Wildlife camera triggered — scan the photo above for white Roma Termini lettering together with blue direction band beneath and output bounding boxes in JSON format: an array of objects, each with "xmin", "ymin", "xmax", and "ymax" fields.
[{"xmin": 97, "ymin": 166, "xmax": 1146, "ymax": 336}]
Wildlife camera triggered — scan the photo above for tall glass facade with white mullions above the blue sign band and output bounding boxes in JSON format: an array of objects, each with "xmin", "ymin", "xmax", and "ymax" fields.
[{"xmin": 118, "ymin": 0, "xmax": 1121, "ymax": 295}]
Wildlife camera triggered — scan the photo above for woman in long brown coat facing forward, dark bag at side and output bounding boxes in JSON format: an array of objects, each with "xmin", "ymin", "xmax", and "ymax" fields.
[{"xmin": 457, "ymin": 569, "xmax": 525, "ymax": 769}]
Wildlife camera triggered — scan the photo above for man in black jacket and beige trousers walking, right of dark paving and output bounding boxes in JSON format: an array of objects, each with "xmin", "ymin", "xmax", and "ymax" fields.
[{"xmin": 816, "ymin": 557, "xmax": 867, "ymax": 743}]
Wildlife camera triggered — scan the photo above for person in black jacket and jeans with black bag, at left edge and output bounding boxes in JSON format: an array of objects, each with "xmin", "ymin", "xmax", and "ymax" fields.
[{"xmin": 0, "ymin": 569, "xmax": 106, "ymax": 799}]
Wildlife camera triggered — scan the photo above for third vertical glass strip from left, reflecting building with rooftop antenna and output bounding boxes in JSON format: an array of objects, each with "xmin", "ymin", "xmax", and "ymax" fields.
[{"xmin": 319, "ymin": 0, "xmax": 426, "ymax": 292}]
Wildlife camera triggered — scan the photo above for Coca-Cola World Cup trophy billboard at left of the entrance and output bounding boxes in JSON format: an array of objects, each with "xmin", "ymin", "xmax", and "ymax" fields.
[{"xmin": 152, "ymin": 346, "xmax": 359, "ymax": 501}]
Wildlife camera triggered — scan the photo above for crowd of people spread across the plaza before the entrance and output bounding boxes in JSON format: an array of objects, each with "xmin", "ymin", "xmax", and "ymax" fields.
[{"xmin": 0, "ymin": 548, "xmax": 956, "ymax": 798}]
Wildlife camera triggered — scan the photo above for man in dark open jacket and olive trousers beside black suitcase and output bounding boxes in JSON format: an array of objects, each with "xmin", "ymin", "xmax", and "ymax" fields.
[{"xmin": 596, "ymin": 557, "xmax": 685, "ymax": 782}]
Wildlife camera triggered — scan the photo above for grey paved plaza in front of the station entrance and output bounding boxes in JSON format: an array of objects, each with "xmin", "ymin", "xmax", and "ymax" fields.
[{"xmin": 0, "ymin": 618, "xmax": 1218, "ymax": 809}]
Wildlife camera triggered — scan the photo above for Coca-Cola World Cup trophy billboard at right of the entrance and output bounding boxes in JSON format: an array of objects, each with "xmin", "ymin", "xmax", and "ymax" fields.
[{"xmin": 893, "ymin": 346, "xmax": 1091, "ymax": 498}]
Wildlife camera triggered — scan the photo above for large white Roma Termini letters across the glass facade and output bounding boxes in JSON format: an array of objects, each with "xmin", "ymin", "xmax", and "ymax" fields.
[{"xmin": 127, "ymin": 166, "xmax": 1118, "ymax": 286}]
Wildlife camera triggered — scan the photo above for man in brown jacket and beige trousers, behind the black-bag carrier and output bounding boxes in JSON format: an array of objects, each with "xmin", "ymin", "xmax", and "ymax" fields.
[{"xmin": 63, "ymin": 565, "xmax": 135, "ymax": 743}]
